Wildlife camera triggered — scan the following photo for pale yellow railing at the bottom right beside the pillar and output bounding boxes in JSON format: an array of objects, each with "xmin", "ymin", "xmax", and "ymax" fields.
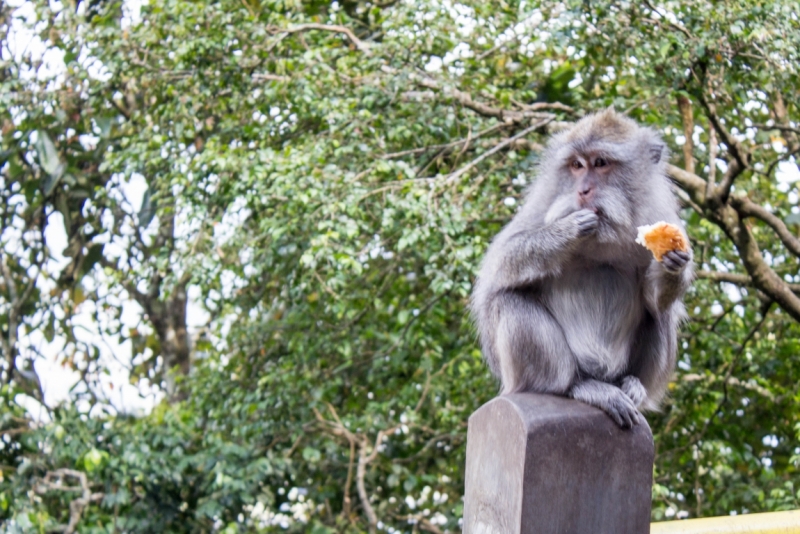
[{"xmin": 650, "ymin": 510, "xmax": 800, "ymax": 534}]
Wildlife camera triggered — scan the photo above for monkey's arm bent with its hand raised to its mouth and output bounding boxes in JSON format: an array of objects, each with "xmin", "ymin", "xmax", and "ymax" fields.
[{"xmin": 479, "ymin": 210, "xmax": 598, "ymax": 294}]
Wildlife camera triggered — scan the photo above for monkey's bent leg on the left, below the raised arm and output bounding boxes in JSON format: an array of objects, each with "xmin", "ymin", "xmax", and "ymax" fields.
[{"xmin": 495, "ymin": 292, "xmax": 577, "ymax": 395}]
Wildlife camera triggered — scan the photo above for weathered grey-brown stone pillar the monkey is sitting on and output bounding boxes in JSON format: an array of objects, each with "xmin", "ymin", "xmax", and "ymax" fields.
[{"xmin": 463, "ymin": 393, "xmax": 654, "ymax": 534}]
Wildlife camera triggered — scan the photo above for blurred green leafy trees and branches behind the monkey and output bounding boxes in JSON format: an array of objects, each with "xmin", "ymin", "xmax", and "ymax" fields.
[{"xmin": 0, "ymin": 0, "xmax": 800, "ymax": 534}]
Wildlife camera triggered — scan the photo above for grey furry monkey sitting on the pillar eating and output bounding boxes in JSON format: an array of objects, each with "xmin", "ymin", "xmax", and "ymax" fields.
[{"xmin": 470, "ymin": 108, "xmax": 693, "ymax": 428}]
